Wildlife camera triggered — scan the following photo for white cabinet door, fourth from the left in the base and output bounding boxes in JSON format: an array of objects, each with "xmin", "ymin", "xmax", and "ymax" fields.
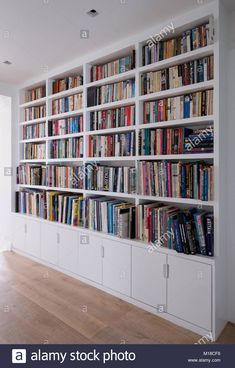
[{"xmin": 59, "ymin": 229, "xmax": 78, "ymax": 273}]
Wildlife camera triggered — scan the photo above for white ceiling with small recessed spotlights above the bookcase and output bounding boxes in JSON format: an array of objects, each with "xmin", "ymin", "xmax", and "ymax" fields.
[{"xmin": 0, "ymin": 0, "xmax": 225, "ymax": 84}]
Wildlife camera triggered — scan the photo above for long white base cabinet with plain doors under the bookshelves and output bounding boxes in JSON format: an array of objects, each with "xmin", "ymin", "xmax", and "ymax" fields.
[{"xmin": 12, "ymin": 214, "xmax": 217, "ymax": 336}]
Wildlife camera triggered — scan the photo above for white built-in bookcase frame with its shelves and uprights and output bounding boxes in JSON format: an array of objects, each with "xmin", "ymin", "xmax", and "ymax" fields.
[{"xmin": 13, "ymin": 1, "xmax": 226, "ymax": 338}]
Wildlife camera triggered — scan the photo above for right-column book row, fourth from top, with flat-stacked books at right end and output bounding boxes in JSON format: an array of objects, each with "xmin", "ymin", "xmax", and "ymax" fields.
[{"xmin": 139, "ymin": 126, "xmax": 214, "ymax": 155}]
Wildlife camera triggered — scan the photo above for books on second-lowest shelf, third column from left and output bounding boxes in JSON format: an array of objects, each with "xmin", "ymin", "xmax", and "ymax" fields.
[{"xmin": 86, "ymin": 164, "xmax": 136, "ymax": 193}]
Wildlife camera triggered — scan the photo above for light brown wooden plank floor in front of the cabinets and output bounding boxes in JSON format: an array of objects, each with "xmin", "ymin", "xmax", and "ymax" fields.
[{"xmin": 0, "ymin": 252, "xmax": 235, "ymax": 344}]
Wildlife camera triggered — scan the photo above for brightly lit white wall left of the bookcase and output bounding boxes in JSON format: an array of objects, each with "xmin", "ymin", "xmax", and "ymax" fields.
[{"xmin": 0, "ymin": 83, "xmax": 17, "ymax": 250}]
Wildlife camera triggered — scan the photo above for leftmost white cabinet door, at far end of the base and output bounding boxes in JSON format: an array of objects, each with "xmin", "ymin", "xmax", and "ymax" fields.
[{"xmin": 12, "ymin": 215, "xmax": 27, "ymax": 252}]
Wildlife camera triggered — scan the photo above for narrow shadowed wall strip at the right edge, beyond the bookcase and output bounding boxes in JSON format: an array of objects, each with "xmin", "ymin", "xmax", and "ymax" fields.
[{"xmin": 227, "ymin": 12, "xmax": 235, "ymax": 323}]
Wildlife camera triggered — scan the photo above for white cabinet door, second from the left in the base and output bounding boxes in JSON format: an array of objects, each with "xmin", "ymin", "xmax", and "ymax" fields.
[{"xmin": 26, "ymin": 219, "xmax": 41, "ymax": 258}]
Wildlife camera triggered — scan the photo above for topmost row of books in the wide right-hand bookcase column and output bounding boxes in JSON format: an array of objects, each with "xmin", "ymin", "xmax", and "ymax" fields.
[{"xmin": 142, "ymin": 23, "xmax": 211, "ymax": 65}]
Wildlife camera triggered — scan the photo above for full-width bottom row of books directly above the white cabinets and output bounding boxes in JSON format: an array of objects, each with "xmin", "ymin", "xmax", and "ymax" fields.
[{"xmin": 16, "ymin": 189, "xmax": 214, "ymax": 256}]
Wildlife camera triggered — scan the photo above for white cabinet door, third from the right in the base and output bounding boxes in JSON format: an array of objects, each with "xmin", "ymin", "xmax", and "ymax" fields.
[{"xmin": 103, "ymin": 239, "xmax": 131, "ymax": 296}]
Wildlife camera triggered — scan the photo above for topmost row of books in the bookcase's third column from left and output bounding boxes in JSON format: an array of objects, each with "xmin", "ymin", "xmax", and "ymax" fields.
[{"xmin": 91, "ymin": 50, "xmax": 135, "ymax": 82}]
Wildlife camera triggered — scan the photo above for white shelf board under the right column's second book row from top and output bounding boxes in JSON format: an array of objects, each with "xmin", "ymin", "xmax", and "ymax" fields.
[{"xmin": 139, "ymin": 80, "xmax": 214, "ymax": 101}]
